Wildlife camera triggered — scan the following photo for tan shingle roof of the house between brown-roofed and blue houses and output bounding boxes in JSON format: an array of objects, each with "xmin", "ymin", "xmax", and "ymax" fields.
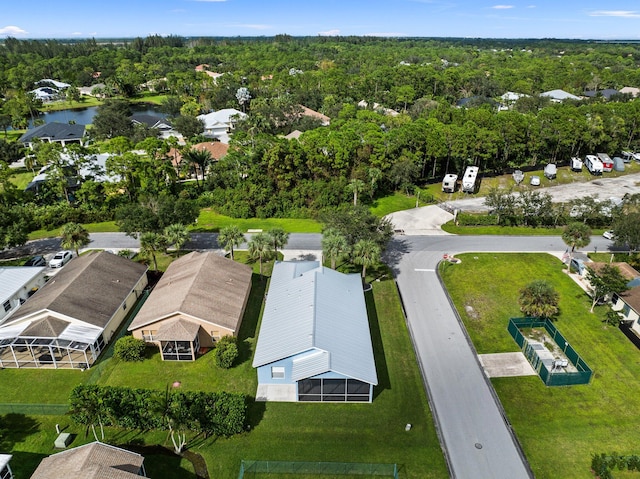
[{"xmin": 129, "ymin": 251, "xmax": 252, "ymax": 331}]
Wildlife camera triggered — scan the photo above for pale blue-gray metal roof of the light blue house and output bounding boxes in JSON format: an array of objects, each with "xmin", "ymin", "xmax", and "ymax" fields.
[{"xmin": 253, "ymin": 261, "xmax": 378, "ymax": 385}]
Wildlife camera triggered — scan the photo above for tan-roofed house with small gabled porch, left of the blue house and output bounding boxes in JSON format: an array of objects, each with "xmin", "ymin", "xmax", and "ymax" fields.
[{"xmin": 129, "ymin": 251, "xmax": 252, "ymax": 361}]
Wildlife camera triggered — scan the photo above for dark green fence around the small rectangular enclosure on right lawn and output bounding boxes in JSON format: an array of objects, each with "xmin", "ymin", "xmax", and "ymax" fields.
[{"xmin": 507, "ymin": 318, "xmax": 593, "ymax": 386}]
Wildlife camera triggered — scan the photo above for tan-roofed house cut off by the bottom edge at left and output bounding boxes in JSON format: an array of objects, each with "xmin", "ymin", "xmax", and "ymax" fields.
[{"xmin": 31, "ymin": 442, "xmax": 147, "ymax": 479}]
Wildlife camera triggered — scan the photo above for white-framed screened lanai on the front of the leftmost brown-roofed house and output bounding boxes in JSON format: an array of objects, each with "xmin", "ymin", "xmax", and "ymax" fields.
[{"xmin": 0, "ymin": 317, "xmax": 104, "ymax": 369}]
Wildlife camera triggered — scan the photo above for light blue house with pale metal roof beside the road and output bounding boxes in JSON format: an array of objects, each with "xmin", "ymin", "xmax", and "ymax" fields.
[{"xmin": 253, "ymin": 261, "xmax": 378, "ymax": 402}]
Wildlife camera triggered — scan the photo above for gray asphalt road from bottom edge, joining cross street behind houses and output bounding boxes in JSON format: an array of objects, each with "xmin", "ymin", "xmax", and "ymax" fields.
[{"xmin": 2, "ymin": 233, "xmax": 612, "ymax": 479}]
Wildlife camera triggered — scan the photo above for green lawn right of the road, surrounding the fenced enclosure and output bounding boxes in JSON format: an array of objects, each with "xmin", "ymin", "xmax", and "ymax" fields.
[{"xmin": 442, "ymin": 254, "xmax": 640, "ymax": 479}]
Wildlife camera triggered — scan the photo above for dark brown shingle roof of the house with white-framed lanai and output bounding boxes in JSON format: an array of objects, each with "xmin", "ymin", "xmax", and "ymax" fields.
[{"xmin": 4, "ymin": 251, "xmax": 147, "ymax": 328}]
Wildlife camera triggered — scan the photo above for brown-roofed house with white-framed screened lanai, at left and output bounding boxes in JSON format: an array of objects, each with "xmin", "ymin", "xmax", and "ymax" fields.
[{"xmin": 0, "ymin": 251, "xmax": 147, "ymax": 369}]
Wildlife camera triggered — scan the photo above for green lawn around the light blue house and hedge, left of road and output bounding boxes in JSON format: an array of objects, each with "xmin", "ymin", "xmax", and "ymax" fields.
[{"xmin": 0, "ymin": 252, "xmax": 448, "ymax": 479}]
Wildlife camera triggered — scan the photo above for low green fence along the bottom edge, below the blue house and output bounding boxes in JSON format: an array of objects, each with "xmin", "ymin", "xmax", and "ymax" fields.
[{"xmin": 238, "ymin": 461, "xmax": 398, "ymax": 479}]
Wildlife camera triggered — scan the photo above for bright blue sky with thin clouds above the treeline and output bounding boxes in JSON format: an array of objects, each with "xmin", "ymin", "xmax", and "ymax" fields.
[{"xmin": 0, "ymin": 0, "xmax": 640, "ymax": 40}]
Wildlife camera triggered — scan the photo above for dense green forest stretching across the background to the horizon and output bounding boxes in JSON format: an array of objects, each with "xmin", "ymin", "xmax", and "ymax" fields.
[{"xmin": 0, "ymin": 35, "xmax": 640, "ymax": 244}]
